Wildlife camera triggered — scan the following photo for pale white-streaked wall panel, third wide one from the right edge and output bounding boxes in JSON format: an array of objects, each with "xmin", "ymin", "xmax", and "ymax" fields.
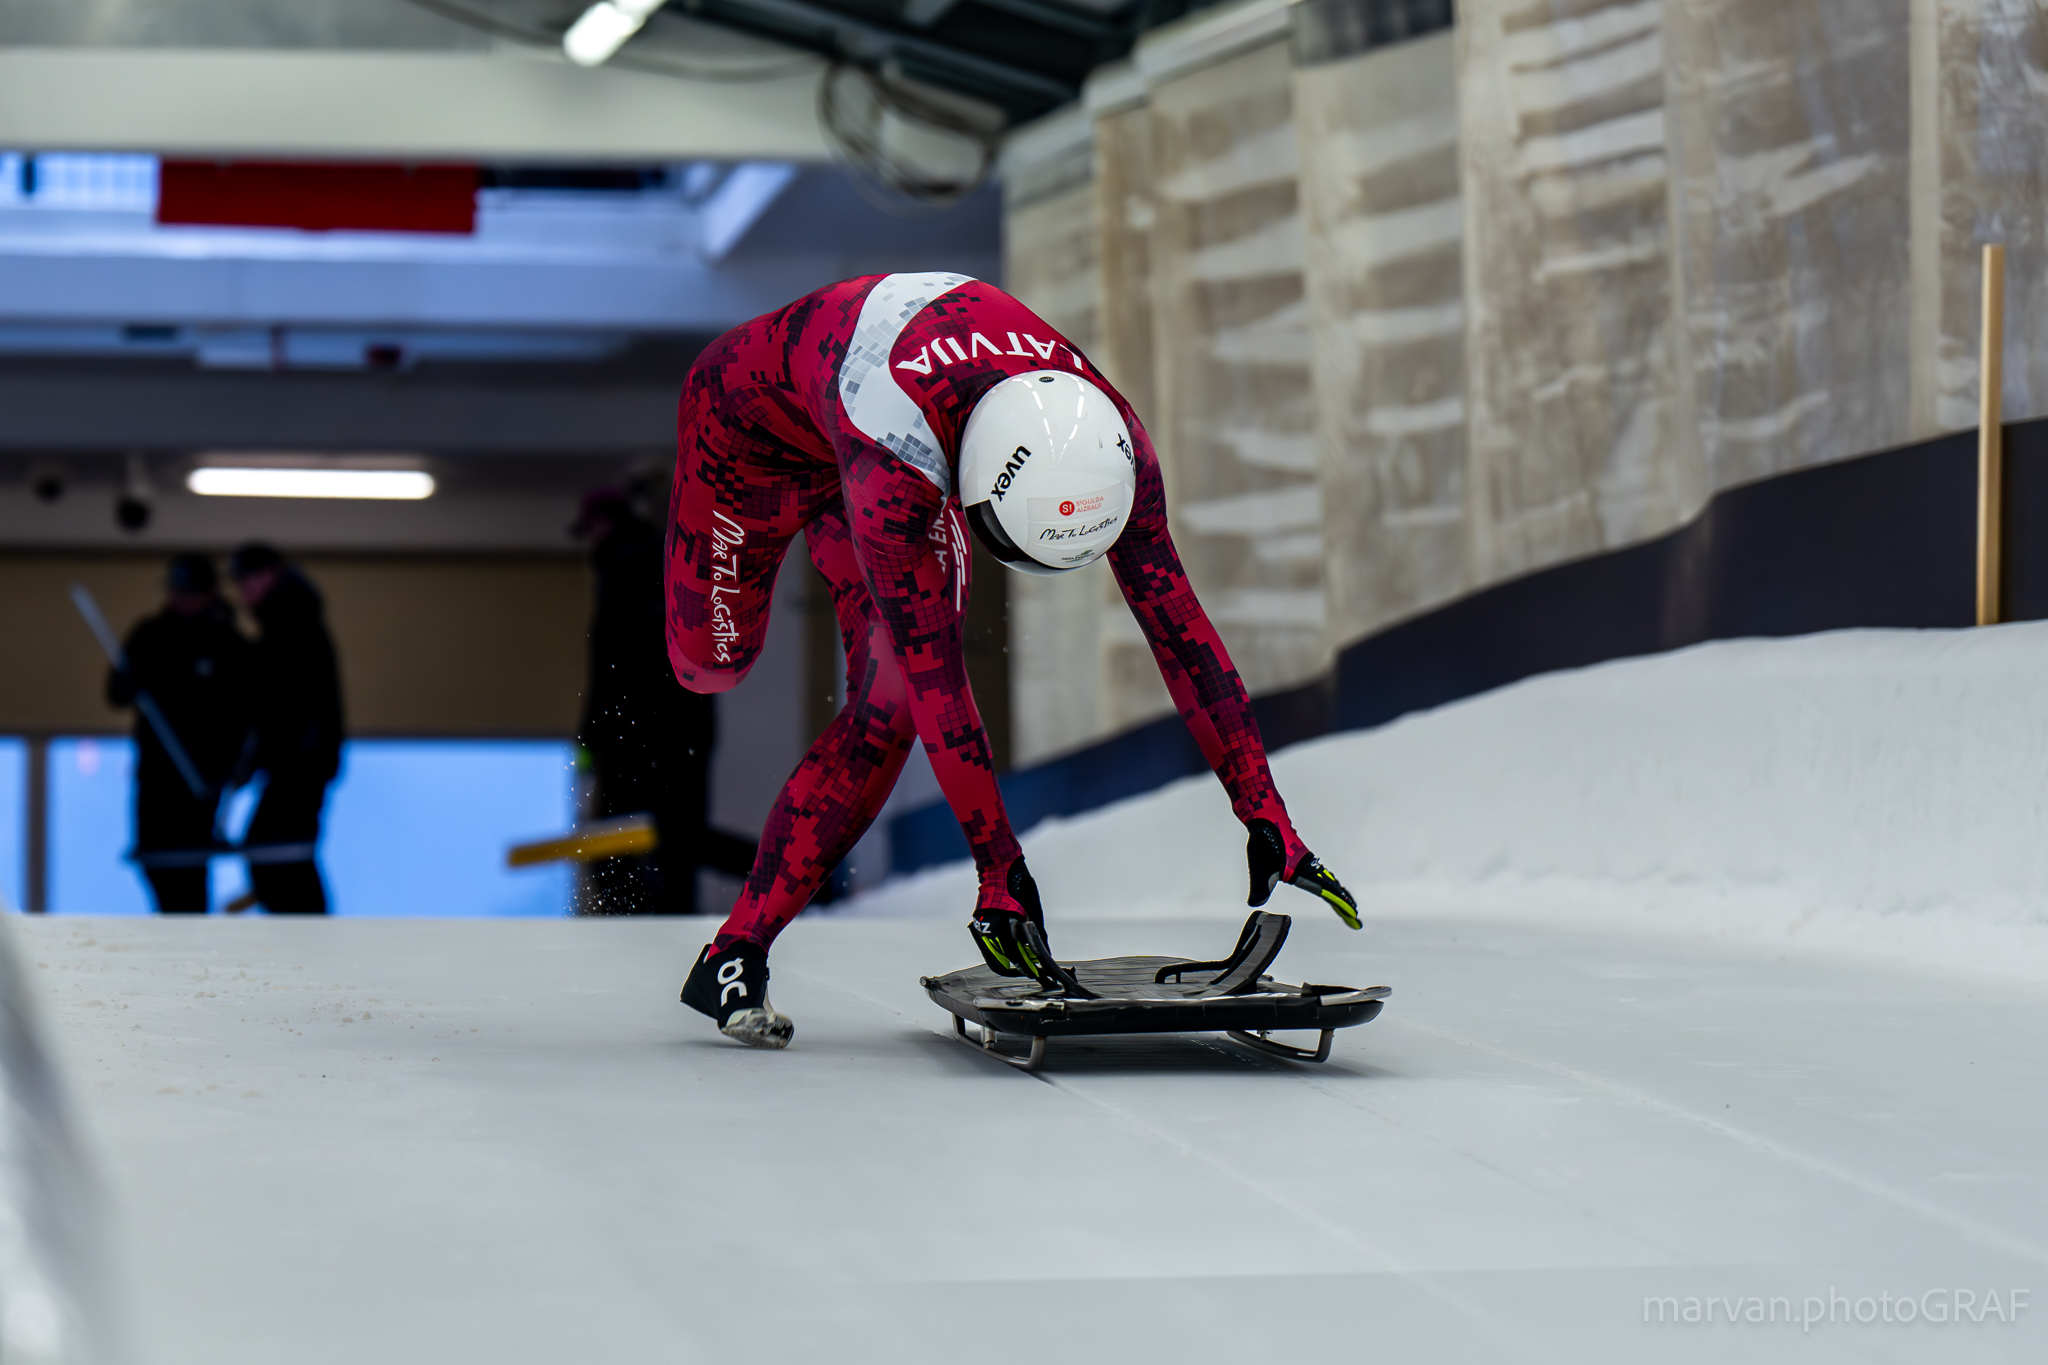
[{"xmin": 1458, "ymin": 0, "xmax": 1706, "ymax": 585}]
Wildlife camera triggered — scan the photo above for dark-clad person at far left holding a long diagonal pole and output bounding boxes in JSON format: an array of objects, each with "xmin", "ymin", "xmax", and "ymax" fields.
[{"xmin": 106, "ymin": 555, "xmax": 252, "ymax": 915}]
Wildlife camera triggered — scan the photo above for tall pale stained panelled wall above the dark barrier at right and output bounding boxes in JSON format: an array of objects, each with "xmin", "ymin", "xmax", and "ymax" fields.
[{"xmin": 1012, "ymin": 0, "xmax": 2048, "ymax": 757}]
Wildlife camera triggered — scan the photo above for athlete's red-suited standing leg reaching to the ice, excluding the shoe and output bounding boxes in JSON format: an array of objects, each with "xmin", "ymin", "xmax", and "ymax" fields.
[{"xmin": 713, "ymin": 505, "xmax": 918, "ymax": 950}]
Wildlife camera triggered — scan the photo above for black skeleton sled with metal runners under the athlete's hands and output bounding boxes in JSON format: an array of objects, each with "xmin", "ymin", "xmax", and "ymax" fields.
[{"xmin": 920, "ymin": 911, "xmax": 1393, "ymax": 1070}]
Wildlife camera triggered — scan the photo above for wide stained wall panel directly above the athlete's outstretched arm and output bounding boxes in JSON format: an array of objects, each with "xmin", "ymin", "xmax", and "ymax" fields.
[{"xmin": 1133, "ymin": 37, "xmax": 1329, "ymax": 699}]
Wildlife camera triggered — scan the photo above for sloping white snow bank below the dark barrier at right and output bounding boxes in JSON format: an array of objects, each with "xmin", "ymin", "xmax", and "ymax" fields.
[{"xmin": 852, "ymin": 624, "xmax": 2048, "ymax": 978}]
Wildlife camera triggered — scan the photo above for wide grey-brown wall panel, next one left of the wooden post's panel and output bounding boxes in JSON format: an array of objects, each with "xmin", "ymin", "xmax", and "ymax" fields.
[{"xmin": 1665, "ymin": 0, "xmax": 1908, "ymax": 489}]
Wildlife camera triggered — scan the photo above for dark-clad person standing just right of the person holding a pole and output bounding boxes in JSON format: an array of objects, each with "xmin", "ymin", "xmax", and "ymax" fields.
[{"xmin": 227, "ymin": 540, "xmax": 342, "ymax": 915}]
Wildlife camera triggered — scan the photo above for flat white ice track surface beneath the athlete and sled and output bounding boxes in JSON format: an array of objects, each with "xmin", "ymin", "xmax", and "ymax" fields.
[{"xmin": 20, "ymin": 915, "xmax": 2048, "ymax": 1365}]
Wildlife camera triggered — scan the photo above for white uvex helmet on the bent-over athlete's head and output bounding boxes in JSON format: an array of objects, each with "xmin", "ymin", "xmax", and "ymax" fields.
[{"xmin": 961, "ymin": 370, "xmax": 1139, "ymax": 573}]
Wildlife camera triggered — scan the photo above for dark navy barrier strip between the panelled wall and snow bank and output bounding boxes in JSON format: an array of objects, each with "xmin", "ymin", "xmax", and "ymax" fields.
[{"xmin": 889, "ymin": 417, "xmax": 2048, "ymax": 872}]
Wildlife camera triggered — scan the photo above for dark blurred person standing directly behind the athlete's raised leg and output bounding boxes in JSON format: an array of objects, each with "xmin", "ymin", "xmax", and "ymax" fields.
[{"xmin": 571, "ymin": 487, "xmax": 754, "ymax": 915}]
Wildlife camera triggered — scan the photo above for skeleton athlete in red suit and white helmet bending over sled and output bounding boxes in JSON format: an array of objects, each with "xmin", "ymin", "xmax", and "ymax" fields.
[{"xmin": 666, "ymin": 274, "xmax": 1358, "ymax": 1048}]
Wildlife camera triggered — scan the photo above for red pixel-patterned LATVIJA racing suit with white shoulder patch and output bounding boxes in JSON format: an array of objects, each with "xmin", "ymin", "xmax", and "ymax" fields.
[{"xmin": 668, "ymin": 274, "xmax": 1307, "ymax": 950}]
